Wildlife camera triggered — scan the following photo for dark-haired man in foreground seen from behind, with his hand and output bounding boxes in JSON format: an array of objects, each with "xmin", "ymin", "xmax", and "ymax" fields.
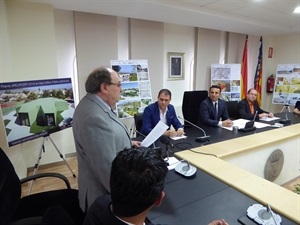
[{"xmin": 83, "ymin": 147, "xmax": 228, "ymax": 225}]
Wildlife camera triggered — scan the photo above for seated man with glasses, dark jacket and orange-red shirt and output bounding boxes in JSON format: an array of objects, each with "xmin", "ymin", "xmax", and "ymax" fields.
[{"xmin": 238, "ymin": 88, "xmax": 274, "ymax": 120}]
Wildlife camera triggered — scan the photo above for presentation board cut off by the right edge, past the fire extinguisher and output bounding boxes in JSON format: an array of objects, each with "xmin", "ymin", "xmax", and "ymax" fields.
[{"xmin": 272, "ymin": 64, "xmax": 300, "ymax": 106}]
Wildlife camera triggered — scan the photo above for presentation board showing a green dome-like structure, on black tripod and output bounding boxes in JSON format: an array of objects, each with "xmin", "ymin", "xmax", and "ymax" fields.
[{"xmin": 0, "ymin": 78, "xmax": 75, "ymax": 147}]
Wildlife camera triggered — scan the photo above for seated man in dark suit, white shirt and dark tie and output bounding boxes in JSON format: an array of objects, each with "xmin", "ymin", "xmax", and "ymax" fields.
[{"xmin": 199, "ymin": 85, "xmax": 233, "ymax": 127}]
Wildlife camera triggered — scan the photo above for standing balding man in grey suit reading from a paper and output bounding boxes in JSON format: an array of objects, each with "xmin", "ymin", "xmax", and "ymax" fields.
[{"xmin": 73, "ymin": 67, "xmax": 140, "ymax": 212}]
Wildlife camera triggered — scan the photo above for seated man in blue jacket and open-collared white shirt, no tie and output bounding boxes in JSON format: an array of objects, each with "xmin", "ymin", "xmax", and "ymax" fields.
[{"xmin": 140, "ymin": 89, "xmax": 184, "ymax": 137}]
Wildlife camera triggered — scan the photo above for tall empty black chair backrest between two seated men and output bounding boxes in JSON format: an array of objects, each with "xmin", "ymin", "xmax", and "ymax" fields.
[{"xmin": 182, "ymin": 90, "xmax": 208, "ymax": 125}]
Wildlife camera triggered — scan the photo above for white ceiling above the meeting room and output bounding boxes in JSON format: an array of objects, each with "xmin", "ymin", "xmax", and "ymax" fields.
[{"xmin": 23, "ymin": 0, "xmax": 300, "ymax": 36}]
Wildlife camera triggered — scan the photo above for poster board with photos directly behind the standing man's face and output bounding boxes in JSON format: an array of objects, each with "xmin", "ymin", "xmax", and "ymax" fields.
[{"xmin": 110, "ymin": 59, "xmax": 152, "ymax": 118}]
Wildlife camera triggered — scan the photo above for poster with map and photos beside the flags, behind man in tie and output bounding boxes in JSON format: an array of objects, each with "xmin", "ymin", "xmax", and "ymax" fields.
[{"xmin": 211, "ymin": 64, "xmax": 241, "ymax": 101}]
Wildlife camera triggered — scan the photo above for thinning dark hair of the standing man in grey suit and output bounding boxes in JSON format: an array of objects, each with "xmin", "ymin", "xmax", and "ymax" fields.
[{"xmin": 85, "ymin": 67, "xmax": 111, "ymax": 94}]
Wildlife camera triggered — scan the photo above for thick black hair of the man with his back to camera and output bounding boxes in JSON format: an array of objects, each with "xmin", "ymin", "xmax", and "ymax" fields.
[{"xmin": 110, "ymin": 147, "xmax": 168, "ymax": 217}]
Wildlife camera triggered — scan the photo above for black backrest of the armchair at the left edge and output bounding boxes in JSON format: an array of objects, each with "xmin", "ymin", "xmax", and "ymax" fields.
[{"xmin": 0, "ymin": 148, "xmax": 21, "ymax": 225}]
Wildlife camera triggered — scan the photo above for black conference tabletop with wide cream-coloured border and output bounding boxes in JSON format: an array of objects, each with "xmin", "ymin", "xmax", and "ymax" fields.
[{"xmin": 149, "ymin": 113, "xmax": 300, "ymax": 225}]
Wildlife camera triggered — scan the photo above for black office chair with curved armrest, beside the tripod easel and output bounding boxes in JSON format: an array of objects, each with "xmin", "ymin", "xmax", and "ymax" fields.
[{"xmin": 0, "ymin": 148, "xmax": 84, "ymax": 225}]
